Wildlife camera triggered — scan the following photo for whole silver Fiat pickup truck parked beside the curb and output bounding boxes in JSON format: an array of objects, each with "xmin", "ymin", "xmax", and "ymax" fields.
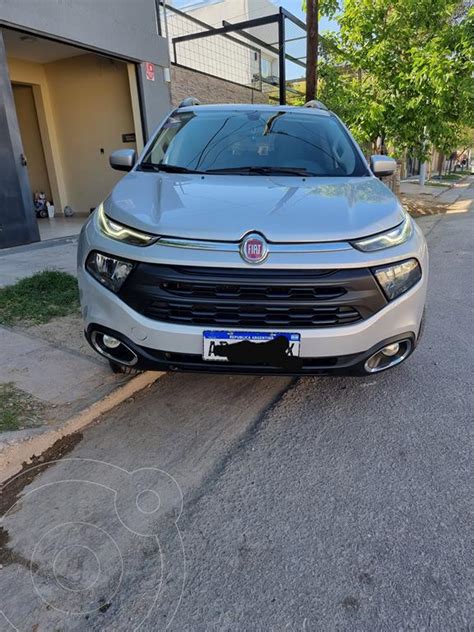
[{"xmin": 78, "ymin": 100, "xmax": 428, "ymax": 375}]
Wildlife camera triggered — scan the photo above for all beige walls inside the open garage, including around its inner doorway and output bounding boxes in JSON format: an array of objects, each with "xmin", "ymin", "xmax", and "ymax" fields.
[{"xmin": 8, "ymin": 54, "xmax": 137, "ymax": 213}]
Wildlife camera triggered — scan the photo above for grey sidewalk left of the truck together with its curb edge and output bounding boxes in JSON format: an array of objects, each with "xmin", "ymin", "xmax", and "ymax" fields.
[{"xmin": 0, "ymin": 237, "xmax": 160, "ymax": 474}]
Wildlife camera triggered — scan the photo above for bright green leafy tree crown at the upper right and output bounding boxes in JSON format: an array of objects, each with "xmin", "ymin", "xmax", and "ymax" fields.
[{"xmin": 318, "ymin": 0, "xmax": 474, "ymax": 159}]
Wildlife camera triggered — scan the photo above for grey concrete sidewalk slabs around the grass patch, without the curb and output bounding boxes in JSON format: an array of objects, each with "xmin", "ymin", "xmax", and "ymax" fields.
[{"xmin": 0, "ymin": 237, "xmax": 126, "ymax": 438}]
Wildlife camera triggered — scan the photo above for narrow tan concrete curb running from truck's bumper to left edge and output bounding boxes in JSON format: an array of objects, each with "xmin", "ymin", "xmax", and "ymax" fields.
[{"xmin": 0, "ymin": 371, "xmax": 166, "ymax": 483}]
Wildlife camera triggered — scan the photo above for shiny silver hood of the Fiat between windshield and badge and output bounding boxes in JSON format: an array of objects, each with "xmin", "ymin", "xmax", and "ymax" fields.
[{"xmin": 104, "ymin": 171, "xmax": 404, "ymax": 242}]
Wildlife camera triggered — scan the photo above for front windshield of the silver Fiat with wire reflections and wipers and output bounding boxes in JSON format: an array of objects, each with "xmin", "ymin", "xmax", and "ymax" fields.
[{"xmin": 139, "ymin": 108, "xmax": 368, "ymax": 176}]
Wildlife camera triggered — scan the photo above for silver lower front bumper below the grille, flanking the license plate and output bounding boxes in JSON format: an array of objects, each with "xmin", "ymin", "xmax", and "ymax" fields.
[{"xmin": 80, "ymin": 272, "xmax": 426, "ymax": 374}]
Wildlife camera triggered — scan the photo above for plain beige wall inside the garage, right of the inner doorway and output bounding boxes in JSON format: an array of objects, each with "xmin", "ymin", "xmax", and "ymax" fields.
[{"xmin": 45, "ymin": 54, "xmax": 136, "ymax": 213}]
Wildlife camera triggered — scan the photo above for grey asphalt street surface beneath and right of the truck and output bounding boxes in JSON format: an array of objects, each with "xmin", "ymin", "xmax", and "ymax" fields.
[{"xmin": 0, "ymin": 213, "xmax": 474, "ymax": 632}]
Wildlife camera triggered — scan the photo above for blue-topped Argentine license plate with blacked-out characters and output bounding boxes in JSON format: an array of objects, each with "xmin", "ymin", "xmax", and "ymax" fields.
[{"xmin": 202, "ymin": 331, "xmax": 301, "ymax": 364}]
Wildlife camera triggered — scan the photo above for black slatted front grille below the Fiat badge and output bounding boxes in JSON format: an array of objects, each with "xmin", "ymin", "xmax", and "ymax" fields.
[{"xmin": 120, "ymin": 263, "xmax": 386, "ymax": 330}]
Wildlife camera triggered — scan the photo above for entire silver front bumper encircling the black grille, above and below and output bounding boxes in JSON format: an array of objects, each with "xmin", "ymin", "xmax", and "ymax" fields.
[{"xmin": 78, "ymin": 215, "xmax": 428, "ymax": 374}]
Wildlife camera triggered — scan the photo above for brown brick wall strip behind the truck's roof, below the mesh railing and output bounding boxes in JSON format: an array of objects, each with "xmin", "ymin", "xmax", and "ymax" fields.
[{"xmin": 171, "ymin": 65, "xmax": 268, "ymax": 106}]
